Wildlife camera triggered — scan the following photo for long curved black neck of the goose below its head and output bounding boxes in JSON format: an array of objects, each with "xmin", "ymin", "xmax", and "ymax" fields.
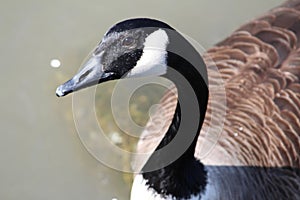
[{"xmin": 142, "ymin": 31, "xmax": 208, "ymax": 198}]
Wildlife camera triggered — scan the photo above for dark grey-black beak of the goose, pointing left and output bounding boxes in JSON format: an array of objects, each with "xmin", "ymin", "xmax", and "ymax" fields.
[{"xmin": 56, "ymin": 56, "xmax": 117, "ymax": 97}]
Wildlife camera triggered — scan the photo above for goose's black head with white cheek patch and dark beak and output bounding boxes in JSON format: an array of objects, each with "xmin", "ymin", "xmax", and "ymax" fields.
[{"xmin": 56, "ymin": 18, "xmax": 177, "ymax": 97}]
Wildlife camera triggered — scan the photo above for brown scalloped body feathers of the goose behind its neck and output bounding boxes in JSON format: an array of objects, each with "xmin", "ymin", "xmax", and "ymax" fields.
[{"xmin": 137, "ymin": 0, "xmax": 300, "ymax": 168}]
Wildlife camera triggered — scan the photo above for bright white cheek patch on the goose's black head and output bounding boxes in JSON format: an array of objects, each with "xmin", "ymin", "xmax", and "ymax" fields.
[{"xmin": 126, "ymin": 29, "xmax": 169, "ymax": 78}]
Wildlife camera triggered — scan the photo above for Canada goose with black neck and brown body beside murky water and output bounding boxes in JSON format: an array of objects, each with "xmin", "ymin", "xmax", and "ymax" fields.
[{"xmin": 56, "ymin": 0, "xmax": 300, "ymax": 200}]
